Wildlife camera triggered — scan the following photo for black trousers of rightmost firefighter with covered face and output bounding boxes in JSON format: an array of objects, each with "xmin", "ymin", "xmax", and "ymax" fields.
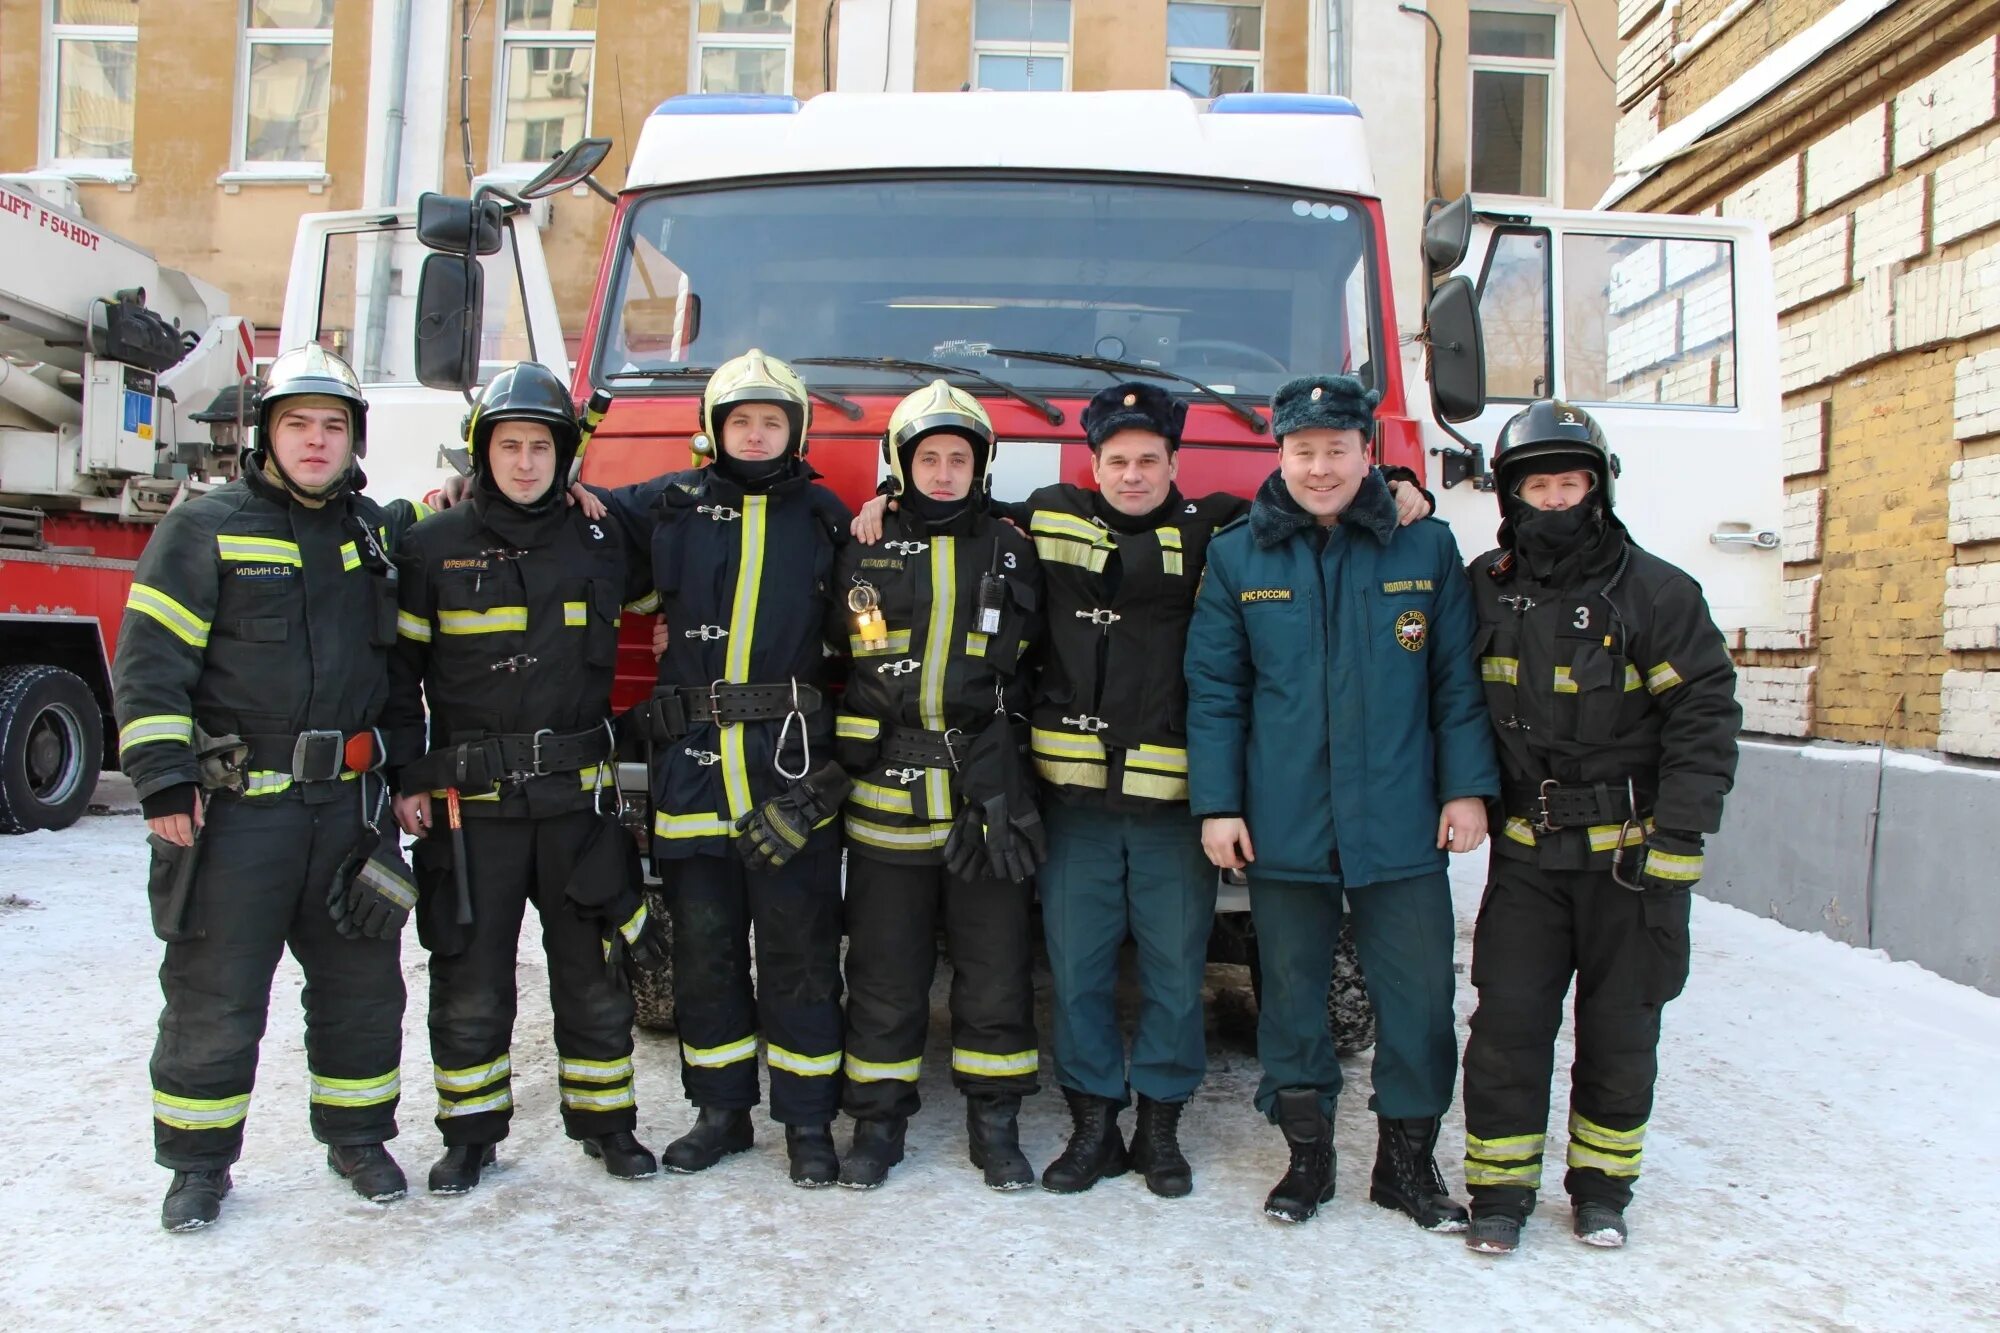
[{"xmin": 1466, "ymin": 857, "xmax": 1690, "ymax": 1217}]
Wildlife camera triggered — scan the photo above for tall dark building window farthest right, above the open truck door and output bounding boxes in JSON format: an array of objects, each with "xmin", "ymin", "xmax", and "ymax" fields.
[{"xmin": 1466, "ymin": 6, "xmax": 1562, "ymax": 200}]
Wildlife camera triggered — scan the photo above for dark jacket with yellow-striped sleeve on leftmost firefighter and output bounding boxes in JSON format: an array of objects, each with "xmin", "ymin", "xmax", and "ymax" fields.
[{"xmin": 112, "ymin": 468, "xmax": 430, "ymax": 803}]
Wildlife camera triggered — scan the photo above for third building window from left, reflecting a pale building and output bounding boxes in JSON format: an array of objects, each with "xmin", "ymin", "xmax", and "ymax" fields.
[{"xmin": 490, "ymin": 0, "xmax": 598, "ymax": 170}]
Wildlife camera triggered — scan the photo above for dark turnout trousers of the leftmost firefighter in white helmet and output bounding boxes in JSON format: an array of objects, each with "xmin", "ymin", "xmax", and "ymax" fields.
[{"xmin": 152, "ymin": 783, "xmax": 404, "ymax": 1171}]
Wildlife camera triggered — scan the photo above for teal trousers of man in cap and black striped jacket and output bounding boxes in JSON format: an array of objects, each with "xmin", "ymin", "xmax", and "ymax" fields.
[{"xmin": 1040, "ymin": 801, "xmax": 1216, "ymax": 1103}]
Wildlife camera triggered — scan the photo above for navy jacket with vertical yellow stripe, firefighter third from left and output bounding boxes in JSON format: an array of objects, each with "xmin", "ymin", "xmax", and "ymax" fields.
[{"xmin": 606, "ymin": 460, "xmax": 852, "ymax": 859}]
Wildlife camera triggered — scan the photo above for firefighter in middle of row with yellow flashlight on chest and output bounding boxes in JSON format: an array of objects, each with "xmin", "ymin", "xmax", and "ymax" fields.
[{"xmin": 830, "ymin": 380, "xmax": 1044, "ymax": 1189}]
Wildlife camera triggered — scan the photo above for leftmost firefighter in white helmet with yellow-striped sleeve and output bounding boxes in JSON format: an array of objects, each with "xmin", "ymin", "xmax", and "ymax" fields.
[{"xmin": 114, "ymin": 346, "xmax": 418, "ymax": 1231}]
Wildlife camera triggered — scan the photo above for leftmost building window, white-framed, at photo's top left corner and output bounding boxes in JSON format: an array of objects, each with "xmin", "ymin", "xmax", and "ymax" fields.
[{"xmin": 44, "ymin": 0, "xmax": 138, "ymax": 174}]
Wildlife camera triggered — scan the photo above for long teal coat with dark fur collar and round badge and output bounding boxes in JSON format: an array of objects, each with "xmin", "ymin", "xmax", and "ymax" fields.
[{"xmin": 1186, "ymin": 472, "xmax": 1500, "ymax": 885}]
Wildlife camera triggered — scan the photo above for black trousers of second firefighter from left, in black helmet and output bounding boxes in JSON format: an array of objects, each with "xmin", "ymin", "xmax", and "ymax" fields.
[{"xmin": 426, "ymin": 811, "xmax": 638, "ymax": 1147}]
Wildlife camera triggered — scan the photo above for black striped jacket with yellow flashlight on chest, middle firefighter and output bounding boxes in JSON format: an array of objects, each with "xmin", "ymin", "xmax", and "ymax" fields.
[{"xmin": 828, "ymin": 506, "xmax": 1042, "ymax": 865}]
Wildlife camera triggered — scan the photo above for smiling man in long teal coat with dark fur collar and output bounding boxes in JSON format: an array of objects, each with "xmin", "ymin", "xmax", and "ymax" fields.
[{"xmin": 1186, "ymin": 376, "xmax": 1500, "ymax": 1231}]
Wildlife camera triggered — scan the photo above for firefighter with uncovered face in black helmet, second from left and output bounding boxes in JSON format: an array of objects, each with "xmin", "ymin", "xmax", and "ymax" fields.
[{"xmin": 384, "ymin": 362, "xmax": 660, "ymax": 1193}]
